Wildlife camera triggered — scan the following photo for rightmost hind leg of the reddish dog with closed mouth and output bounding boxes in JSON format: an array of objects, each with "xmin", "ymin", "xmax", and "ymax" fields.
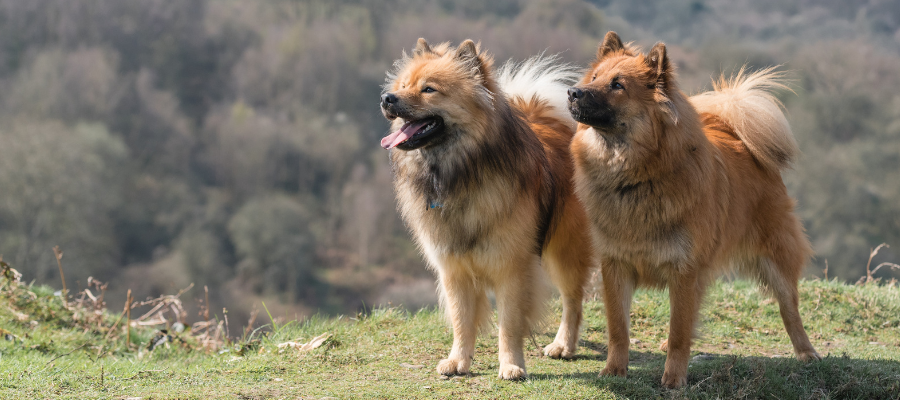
[{"xmin": 758, "ymin": 228, "xmax": 822, "ymax": 361}]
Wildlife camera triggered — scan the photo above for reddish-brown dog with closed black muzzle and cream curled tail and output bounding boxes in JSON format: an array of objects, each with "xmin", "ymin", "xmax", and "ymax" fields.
[{"xmin": 568, "ymin": 32, "xmax": 821, "ymax": 388}]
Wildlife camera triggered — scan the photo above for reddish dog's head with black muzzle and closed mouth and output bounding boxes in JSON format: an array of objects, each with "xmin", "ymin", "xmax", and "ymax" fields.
[{"xmin": 569, "ymin": 32, "xmax": 677, "ymax": 135}]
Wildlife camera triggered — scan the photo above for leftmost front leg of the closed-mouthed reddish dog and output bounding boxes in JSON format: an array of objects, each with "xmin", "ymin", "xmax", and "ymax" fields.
[{"xmin": 600, "ymin": 259, "xmax": 635, "ymax": 376}]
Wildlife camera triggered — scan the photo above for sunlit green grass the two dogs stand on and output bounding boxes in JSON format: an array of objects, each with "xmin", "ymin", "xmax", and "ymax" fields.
[{"xmin": 0, "ymin": 272, "xmax": 900, "ymax": 399}]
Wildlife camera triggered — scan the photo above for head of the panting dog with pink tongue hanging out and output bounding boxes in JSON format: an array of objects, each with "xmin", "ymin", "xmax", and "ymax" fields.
[{"xmin": 381, "ymin": 39, "xmax": 496, "ymax": 150}]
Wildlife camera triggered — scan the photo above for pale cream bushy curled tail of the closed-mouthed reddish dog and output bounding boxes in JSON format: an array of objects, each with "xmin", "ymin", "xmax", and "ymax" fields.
[{"xmin": 691, "ymin": 67, "xmax": 800, "ymax": 172}]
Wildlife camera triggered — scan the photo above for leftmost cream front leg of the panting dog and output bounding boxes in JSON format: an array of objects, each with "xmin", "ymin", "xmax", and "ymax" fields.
[{"xmin": 437, "ymin": 265, "xmax": 490, "ymax": 375}]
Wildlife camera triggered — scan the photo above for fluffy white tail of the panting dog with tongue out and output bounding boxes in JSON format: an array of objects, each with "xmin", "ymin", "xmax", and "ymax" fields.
[{"xmin": 497, "ymin": 54, "xmax": 581, "ymax": 129}]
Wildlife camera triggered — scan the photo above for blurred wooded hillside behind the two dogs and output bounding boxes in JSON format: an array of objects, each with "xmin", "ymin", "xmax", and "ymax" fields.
[{"xmin": 0, "ymin": 0, "xmax": 900, "ymax": 321}]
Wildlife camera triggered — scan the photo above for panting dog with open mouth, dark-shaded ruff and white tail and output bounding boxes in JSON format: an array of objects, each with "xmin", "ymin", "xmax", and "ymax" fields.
[{"xmin": 381, "ymin": 39, "xmax": 594, "ymax": 380}]
